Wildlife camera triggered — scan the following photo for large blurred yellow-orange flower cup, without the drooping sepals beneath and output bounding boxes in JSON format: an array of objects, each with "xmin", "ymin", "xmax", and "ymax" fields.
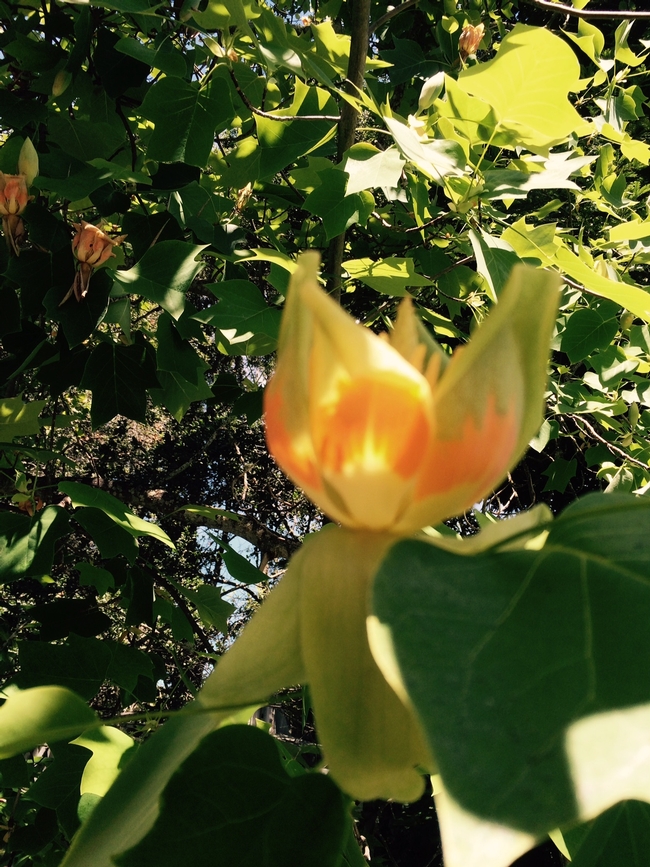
[{"xmin": 265, "ymin": 253, "xmax": 559, "ymax": 534}]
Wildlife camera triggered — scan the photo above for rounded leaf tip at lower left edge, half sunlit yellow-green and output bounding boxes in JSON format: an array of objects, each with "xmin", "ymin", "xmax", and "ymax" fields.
[{"xmin": 0, "ymin": 686, "xmax": 97, "ymax": 759}]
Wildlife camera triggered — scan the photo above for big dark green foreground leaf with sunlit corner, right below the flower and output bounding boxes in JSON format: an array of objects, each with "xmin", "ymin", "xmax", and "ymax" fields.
[{"xmin": 373, "ymin": 494, "xmax": 650, "ymax": 835}]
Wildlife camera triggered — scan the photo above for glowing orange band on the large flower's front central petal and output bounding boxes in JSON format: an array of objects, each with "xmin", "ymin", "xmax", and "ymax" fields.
[{"xmin": 314, "ymin": 377, "xmax": 432, "ymax": 479}]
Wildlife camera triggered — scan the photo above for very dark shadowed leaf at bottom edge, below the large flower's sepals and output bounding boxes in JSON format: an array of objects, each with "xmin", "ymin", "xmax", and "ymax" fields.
[{"xmin": 115, "ymin": 725, "xmax": 347, "ymax": 867}]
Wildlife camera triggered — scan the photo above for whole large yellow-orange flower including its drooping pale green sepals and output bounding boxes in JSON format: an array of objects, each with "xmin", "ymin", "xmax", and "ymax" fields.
[{"xmin": 192, "ymin": 253, "xmax": 559, "ymax": 801}]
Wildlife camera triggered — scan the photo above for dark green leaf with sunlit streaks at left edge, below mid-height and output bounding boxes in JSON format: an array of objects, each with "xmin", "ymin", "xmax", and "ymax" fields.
[{"xmin": 0, "ymin": 506, "xmax": 69, "ymax": 581}]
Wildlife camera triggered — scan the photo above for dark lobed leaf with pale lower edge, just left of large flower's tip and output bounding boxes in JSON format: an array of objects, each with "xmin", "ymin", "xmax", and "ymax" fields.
[{"xmin": 192, "ymin": 280, "xmax": 281, "ymax": 355}]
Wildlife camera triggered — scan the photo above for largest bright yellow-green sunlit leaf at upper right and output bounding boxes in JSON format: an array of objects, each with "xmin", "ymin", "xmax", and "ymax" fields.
[{"xmin": 458, "ymin": 24, "xmax": 591, "ymax": 153}]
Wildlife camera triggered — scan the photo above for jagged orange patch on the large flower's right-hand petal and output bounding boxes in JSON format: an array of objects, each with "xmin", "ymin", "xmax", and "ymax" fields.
[{"xmin": 415, "ymin": 395, "xmax": 519, "ymax": 506}]
